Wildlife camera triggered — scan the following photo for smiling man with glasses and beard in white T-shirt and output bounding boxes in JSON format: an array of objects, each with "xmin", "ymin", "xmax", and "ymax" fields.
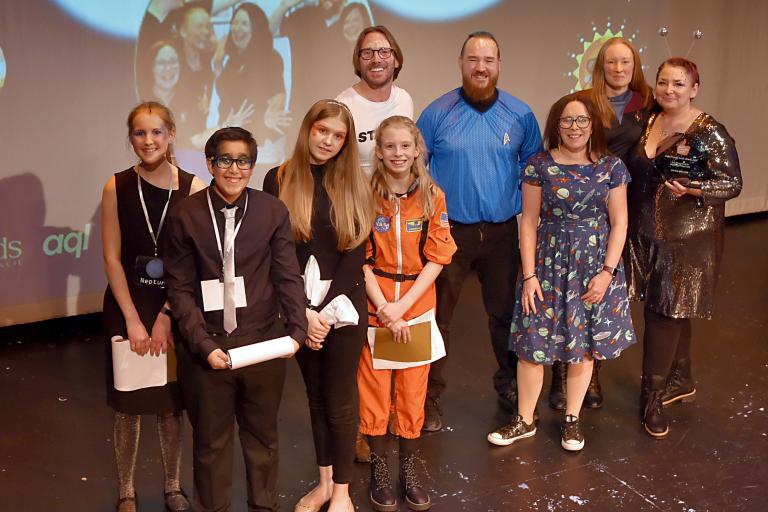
[{"xmin": 336, "ymin": 25, "xmax": 413, "ymax": 176}]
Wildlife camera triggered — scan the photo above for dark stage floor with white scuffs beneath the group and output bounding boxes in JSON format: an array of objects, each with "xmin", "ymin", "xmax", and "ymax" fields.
[{"xmin": 0, "ymin": 214, "xmax": 768, "ymax": 512}]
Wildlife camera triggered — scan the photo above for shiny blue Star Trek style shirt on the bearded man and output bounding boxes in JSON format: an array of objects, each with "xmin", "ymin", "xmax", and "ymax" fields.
[{"xmin": 416, "ymin": 88, "xmax": 541, "ymax": 224}]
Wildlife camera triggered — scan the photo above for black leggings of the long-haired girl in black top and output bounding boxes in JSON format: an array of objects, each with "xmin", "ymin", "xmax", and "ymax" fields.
[{"xmin": 296, "ymin": 322, "xmax": 368, "ymax": 484}]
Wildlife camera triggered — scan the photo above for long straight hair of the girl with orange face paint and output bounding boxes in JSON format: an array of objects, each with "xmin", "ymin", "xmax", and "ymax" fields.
[{"xmin": 277, "ymin": 100, "xmax": 373, "ymax": 252}]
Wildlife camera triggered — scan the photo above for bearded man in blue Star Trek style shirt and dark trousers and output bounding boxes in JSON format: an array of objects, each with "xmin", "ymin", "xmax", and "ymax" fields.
[{"xmin": 417, "ymin": 32, "xmax": 541, "ymax": 432}]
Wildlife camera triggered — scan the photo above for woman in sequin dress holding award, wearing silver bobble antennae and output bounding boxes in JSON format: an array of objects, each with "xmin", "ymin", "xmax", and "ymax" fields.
[{"xmin": 628, "ymin": 57, "xmax": 741, "ymax": 438}]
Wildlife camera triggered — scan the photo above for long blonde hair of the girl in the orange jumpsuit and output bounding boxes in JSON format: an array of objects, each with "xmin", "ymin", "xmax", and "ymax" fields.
[{"xmin": 371, "ymin": 116, "xmax": 435, "ymax": 219}]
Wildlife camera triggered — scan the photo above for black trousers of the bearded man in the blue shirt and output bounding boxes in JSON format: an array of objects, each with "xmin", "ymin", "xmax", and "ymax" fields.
[{"xmin": 427, "ymin": 217, "xmax": 520, "ymax": 398}]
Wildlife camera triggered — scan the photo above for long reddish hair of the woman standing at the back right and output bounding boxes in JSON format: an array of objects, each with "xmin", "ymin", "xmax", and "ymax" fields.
[{"xmin": 590, "ymin": 37, "xmax": 653, "ymax": 128}]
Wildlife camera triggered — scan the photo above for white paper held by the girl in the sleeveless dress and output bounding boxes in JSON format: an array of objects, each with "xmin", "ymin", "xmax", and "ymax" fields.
[{"xmin": 111, "ymin": 336, "xmax": 168, "ymax": 391}]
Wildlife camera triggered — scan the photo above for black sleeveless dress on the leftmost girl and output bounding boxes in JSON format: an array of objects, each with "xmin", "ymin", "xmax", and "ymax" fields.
[{"xmin": 103, "ymin": 168, "xmax": 194, "ymax": 414}]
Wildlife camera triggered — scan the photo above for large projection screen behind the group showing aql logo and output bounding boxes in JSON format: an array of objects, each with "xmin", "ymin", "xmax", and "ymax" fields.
[{"xmin": 0, "ymin": 0, "xmax": 768, "ymax": 325}]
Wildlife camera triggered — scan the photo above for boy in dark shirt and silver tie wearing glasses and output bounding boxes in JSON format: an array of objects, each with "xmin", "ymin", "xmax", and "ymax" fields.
[{"xmin": 165, "ymin": 127, "xmax": 307, "ymax": 511}]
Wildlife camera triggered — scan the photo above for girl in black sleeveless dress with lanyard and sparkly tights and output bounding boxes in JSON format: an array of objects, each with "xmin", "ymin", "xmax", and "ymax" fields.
[{"xmin": 101, "ymin": 102, "xmax": 205, "ymax": 512}]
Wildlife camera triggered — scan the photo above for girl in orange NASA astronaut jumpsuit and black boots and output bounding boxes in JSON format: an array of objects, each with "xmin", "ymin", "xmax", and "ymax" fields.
[{"xmin": 357, "ymin": 116, "xmax": 456, "ymax": 511}]
